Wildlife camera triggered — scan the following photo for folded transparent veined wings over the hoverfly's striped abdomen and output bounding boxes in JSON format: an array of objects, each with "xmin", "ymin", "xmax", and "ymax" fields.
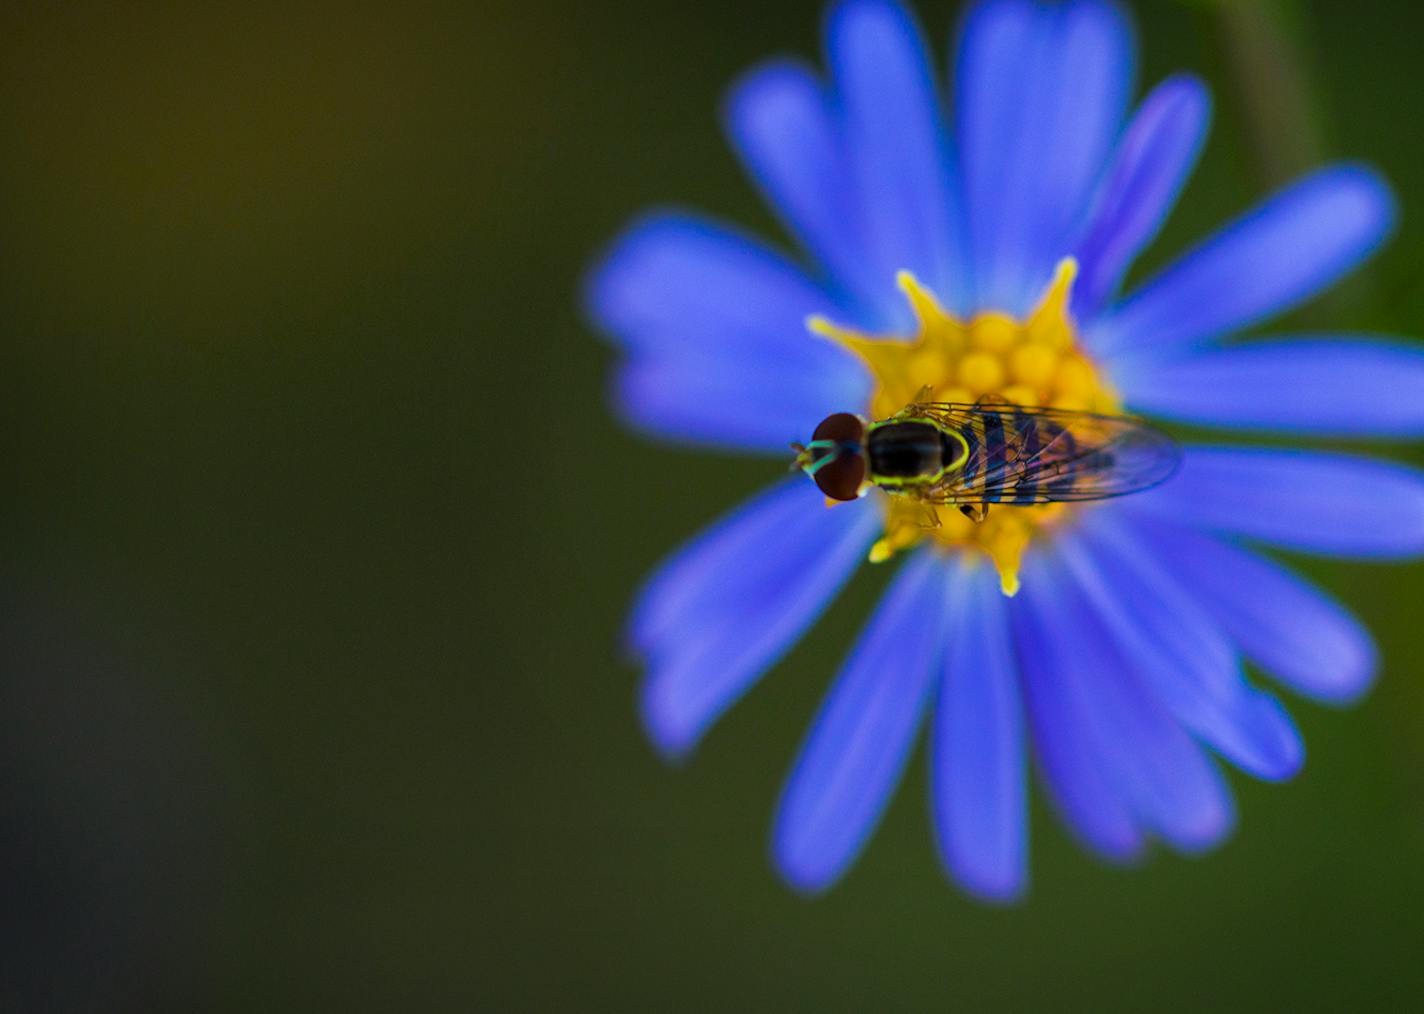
[{"xmin": 906, "ymin": 402, "xmax": 1180, "ymax": 504}]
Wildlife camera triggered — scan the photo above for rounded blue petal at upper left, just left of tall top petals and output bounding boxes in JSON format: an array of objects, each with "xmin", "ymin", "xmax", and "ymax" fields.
[{"xmin": 726, "ymin": 61, "xmax": 886, "ymax": 326}]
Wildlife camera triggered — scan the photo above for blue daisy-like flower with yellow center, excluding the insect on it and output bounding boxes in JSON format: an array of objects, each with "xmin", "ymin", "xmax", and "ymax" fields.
[{"xmin": 588, "ymin": 0, "xmax": 1424, "ymax": 900}]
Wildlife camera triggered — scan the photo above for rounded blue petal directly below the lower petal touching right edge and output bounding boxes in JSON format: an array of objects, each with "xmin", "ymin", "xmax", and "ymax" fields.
[{"xmin": 1138, "ymin": 520, "xmax": 1378, "ymax": 704}]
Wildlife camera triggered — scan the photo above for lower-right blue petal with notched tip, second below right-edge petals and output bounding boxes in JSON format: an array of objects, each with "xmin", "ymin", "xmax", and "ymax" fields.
[{"xmin": 1061, "ymin": 511, "xmax": 1304, "ymax": 780}]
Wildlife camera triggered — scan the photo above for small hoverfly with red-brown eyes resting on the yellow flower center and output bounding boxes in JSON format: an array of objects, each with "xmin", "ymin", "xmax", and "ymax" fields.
[{"xmin": 792, "ymin": 402, "xmax": 1180, "ymax": 526}]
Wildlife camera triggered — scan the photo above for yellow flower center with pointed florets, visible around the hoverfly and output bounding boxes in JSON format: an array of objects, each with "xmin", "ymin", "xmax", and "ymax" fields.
[{"xmin": 807, "ymin": 258, "xmax": 1122, "ymax": 595}]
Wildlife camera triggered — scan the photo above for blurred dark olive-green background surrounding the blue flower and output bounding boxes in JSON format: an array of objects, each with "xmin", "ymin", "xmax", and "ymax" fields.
[{"xmin": 0, "ymin": 0, "xmax": 1424, "ymax": 1011}]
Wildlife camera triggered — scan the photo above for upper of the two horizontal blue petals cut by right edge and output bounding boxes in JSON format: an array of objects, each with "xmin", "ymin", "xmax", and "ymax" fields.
[{"xmin": 1112, "ymin": 338, "xmax": 1424, "ymax": 436}]
